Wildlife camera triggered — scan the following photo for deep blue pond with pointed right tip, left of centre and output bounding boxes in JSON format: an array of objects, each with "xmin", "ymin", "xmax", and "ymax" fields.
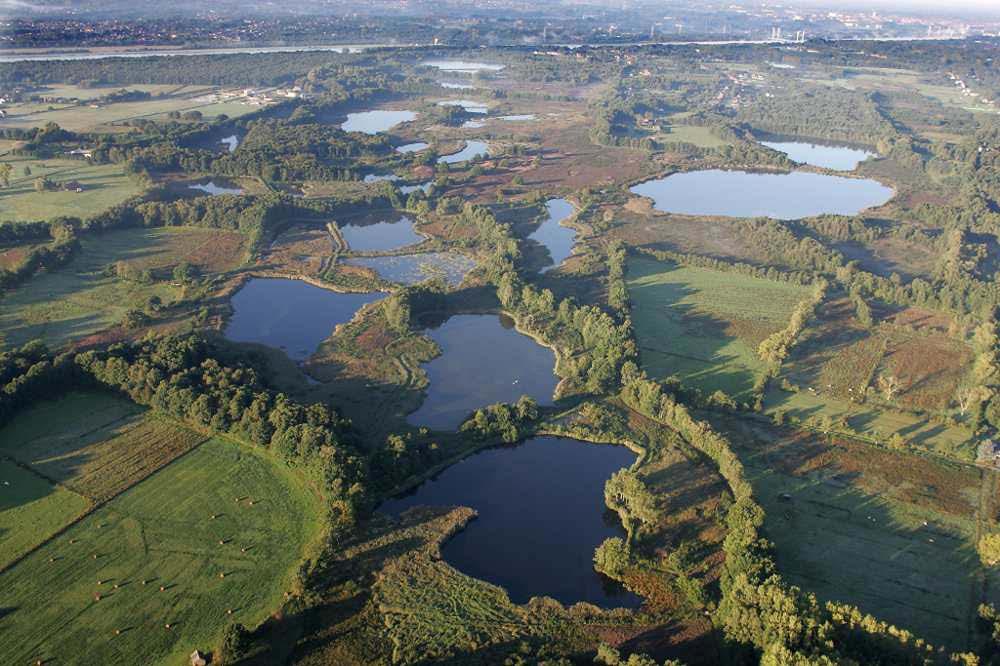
[{"xmin": 225, "ymin": 278, "xmax": 383, "ymax": 361}]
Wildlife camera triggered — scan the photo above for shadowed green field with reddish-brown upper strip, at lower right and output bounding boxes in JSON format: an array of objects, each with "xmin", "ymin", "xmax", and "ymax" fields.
[{"xmin": 716, "ymin": 416, "xmax": 989, "ymax": 649}]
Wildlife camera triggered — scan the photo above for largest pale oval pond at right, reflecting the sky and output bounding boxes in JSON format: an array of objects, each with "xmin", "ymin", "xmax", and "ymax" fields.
[{"xmin": 631, "ymin": 169, "xmax": 893, "ymax": 220}]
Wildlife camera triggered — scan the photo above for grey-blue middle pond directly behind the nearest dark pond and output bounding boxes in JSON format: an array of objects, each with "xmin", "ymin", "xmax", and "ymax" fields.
[{"xmin": 407, "ymin": 314, "xmax": 559, "ymax": 430}]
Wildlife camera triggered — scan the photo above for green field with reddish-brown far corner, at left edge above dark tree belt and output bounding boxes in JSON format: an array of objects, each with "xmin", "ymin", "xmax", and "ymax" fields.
[{"xmin": 0, "ymin": 227, "xmax": 244, "ymax": 346}]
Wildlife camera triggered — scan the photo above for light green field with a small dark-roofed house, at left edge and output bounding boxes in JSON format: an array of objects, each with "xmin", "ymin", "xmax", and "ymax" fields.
[{"xmin": 0, "ymin": 155, "xmax": 140, "ymax": 222}]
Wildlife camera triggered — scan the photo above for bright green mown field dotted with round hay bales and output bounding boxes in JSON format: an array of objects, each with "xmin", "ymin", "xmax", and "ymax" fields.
[{"xmin": 0, "ymin": 439, "xmax": 322, "ymax": 665}]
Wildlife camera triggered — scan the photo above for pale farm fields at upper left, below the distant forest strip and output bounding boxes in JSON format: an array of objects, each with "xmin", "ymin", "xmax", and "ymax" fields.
[{"xmin": 4, "ymin": 85, "xmax": 260, "ymax": 131}]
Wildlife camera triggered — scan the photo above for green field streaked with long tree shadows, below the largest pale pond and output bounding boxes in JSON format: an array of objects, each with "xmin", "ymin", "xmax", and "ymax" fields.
[{"xmin": 627, "ymin": 258, "xmax": 809, "ymax": 398}]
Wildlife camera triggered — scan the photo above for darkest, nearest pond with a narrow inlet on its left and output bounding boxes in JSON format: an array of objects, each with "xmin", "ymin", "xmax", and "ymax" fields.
[{"xmin": 381, "ymin": 437, "xmax": 641, "ymax": 608}]
